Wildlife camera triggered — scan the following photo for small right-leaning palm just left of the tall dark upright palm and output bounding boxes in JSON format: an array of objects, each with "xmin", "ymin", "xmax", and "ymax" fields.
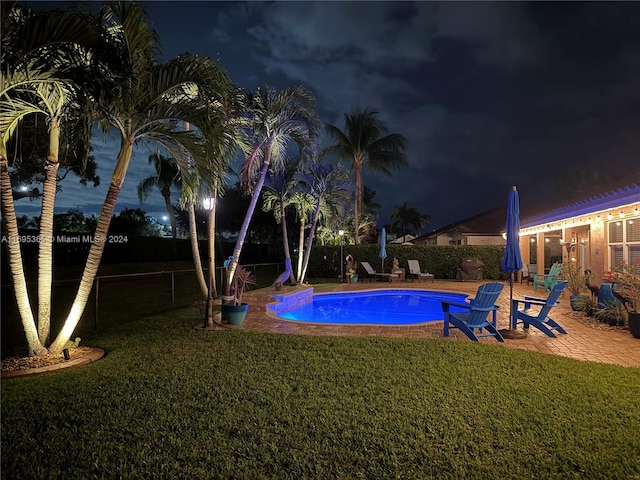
[{"xmin": 296, "ymin": 163, "xmax": 353, "ymax": 283}]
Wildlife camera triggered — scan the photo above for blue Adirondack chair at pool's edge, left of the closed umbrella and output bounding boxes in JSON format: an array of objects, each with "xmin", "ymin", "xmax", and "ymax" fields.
[{"xmin": 441, "ymin": 282, "xmax": 504, "ymax": 342}]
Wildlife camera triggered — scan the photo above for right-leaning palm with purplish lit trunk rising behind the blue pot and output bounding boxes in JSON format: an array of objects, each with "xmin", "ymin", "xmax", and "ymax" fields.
[{"xmin": 225, "ymin": 86, "xmax": 322, "ymax": 297}]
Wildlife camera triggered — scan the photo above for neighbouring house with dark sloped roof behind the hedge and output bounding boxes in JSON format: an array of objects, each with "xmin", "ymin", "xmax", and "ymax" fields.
[{"xmin": 411, "ymin": 207, "xmax": 507, "ymax": 245}]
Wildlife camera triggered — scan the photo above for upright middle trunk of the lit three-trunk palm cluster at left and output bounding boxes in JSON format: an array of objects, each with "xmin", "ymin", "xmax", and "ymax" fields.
[{"xmin": 38, "ymin": 117, "xmax": 60, "ymax": 345}]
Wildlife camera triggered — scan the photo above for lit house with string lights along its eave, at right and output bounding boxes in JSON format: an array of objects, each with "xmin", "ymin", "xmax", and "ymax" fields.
[{"xmin": 520, "ymin": 184, "xmax": 640, "ymax": 280}]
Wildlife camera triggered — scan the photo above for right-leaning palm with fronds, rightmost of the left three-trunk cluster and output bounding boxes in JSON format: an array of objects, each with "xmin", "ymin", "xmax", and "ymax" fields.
[{"xmin": 50, "ymin": 2, "xmax": 230, "ymax": 353}]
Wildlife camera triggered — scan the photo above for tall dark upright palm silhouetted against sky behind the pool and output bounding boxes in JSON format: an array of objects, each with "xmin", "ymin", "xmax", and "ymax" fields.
[{"xmin": 325, "ymin": 108, "xmax": 407, "ymax": 244}]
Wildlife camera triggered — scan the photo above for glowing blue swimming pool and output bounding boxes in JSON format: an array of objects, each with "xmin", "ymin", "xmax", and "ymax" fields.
[{"xmin": 271, "ymin": 290, "xmax": 468, "ymax": 325}]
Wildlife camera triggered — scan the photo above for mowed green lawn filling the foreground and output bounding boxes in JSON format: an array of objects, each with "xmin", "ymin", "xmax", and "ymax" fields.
[{"xmin": 1, "ymin": 309, "xmax": 640, "ymax": 480}]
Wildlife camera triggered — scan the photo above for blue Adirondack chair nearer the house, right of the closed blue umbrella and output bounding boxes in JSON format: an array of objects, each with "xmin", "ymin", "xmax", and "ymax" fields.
[{"xmin": 511, "ymin": 282, "xmax": 567, "ymax": 338}]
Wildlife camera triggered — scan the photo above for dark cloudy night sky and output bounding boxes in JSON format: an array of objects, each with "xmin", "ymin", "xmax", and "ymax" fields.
[{"xmin": 13, "ymin": 1, "xmax": 640, "ymax": 232}]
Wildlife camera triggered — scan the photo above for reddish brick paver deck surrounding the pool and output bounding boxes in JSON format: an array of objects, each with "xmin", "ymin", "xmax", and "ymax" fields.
[{"xmin": 236, "ymin": 279, "xmax": 640, "ymax": 367}]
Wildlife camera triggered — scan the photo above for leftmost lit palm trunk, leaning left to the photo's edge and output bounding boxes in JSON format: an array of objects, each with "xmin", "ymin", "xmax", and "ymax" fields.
[{"xmin": 0, "ymin": 154, "xmax": 47, "ymax": 356}]
